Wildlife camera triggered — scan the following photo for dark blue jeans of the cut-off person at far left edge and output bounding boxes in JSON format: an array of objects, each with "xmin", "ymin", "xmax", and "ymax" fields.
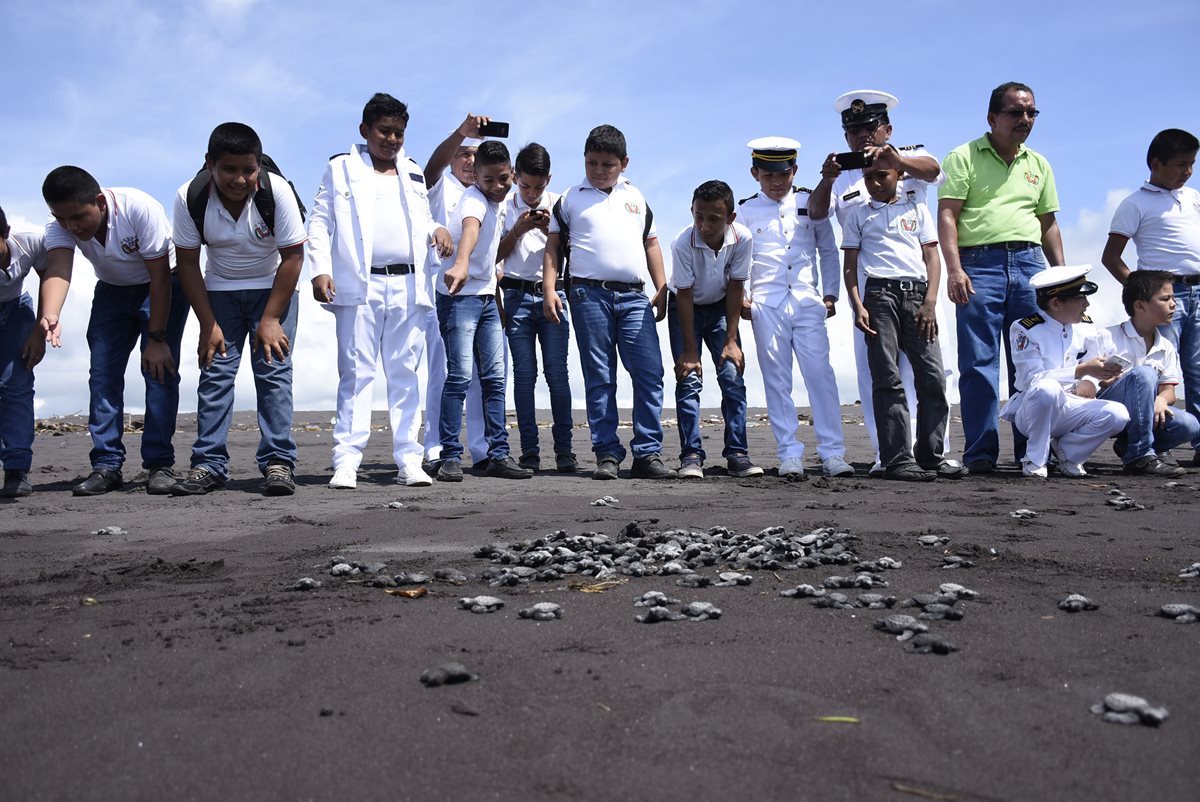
[{"xmin": 0, "ymin": 293, "xmax": 36, "ymax": 471}]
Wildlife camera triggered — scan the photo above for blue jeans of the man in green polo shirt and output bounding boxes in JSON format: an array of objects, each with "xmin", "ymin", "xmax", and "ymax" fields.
[{"xmin": 956, "ymin": 246, "xmax": 1046, "ymax": 465}]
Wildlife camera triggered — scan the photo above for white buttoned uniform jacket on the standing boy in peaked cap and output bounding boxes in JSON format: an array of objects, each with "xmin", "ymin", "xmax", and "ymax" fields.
[{"xmin": 738, "ymin": 188, "xmax": 841, "ymax": 309}]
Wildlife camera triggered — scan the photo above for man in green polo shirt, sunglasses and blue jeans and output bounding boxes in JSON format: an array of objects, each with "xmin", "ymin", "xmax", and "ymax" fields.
[{"xmin": 937, "ymin": 83, "xmax": 1063, "ymax": 473}]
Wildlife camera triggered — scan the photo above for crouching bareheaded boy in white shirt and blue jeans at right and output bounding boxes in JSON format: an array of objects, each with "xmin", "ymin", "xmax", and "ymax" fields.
[{"xmin": 1099, "ymin": 270, "xmax": 1200, "ymax": 478}]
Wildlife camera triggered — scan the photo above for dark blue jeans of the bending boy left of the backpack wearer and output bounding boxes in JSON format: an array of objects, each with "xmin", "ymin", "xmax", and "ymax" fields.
[{"xmin": 88, "ymin": 275, "xmax": 188, "ymax": 471}]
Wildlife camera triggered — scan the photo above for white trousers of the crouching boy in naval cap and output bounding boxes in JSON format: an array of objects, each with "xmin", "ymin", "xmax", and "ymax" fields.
[{"xmin": 1003, "ymin": 378, "xmax": 1129, "ymax": 468}]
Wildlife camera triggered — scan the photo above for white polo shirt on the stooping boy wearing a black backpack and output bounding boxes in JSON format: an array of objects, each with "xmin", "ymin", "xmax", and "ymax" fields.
[{"xmin": 175, "ymin": 174, "xmax": 307, "ymax": 292}]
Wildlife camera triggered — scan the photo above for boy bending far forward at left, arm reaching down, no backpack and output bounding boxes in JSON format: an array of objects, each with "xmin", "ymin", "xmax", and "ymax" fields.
[{"xmin": 41, "ymin": 166, "xmax": 187, "ymax": 496}]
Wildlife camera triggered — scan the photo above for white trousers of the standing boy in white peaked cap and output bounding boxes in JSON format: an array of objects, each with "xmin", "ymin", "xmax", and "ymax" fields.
[{"xmin": 750, "ymin": 297, "xmax": 846, "ymax": 460}]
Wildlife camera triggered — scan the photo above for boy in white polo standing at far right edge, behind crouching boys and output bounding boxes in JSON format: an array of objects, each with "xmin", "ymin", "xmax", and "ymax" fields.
[{"xmin": 1100, "ymin": 128, "xmax": 1200, "ymax": 466}]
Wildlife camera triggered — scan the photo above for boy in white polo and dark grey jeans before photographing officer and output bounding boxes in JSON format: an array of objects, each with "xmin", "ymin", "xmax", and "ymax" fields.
[{"xmin": 841, "ymin": 167, "xmax": 964, "ymax": 481}]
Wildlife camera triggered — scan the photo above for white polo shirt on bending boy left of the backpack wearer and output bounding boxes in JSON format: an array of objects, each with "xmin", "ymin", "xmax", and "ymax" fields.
[{"xmin": 46, "ymin": 187, "xmax": 175, "ymax": 287}]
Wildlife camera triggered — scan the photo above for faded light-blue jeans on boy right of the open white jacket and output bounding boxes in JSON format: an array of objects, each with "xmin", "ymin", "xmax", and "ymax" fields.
[{"xmin": 437, "ymin": 294, "xmax": 509, "ymax": 460}]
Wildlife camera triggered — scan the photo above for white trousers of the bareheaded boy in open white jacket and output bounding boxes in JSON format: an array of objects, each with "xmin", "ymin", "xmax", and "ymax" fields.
[{"xmin": 330, "ymin": 274, "xmax": 426, "ymax": 469}]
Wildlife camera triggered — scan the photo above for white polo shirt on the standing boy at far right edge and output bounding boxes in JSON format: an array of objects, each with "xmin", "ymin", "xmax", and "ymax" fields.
[{"xmin": 1109, "ymin": 181, "xmax": 1200, "ymax": 276}]
